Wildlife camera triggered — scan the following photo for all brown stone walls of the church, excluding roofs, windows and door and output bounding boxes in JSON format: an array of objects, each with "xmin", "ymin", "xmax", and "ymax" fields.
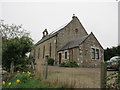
[{"xmin": 31, "ymin": 17, "xmax": 104, "ymax": 67}]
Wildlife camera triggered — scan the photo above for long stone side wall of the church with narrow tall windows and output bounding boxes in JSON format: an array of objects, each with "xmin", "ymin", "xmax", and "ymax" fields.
[{"xmin": 34, "ymin": 36, "xmax": 57, "ymax": 62}]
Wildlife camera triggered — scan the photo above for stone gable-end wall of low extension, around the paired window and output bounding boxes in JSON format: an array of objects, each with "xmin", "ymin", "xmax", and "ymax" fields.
[{"xmin": 79, "ymin": 33, "xmax": 104, "ymax": 67}]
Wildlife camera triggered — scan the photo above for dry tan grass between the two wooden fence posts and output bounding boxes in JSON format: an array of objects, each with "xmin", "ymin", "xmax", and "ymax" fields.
[{"xmin": 39, "ymin": 66, "xmax": 100, "ymax": 88}]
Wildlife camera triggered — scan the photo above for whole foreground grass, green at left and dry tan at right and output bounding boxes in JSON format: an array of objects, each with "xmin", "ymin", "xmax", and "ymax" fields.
[{"xmin": 3, "ymin": 63, "xmax": 100, "ymax": 88}]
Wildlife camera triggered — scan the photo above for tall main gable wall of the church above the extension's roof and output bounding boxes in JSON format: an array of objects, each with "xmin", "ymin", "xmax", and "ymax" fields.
[{"xmin": 57, "ymin": 17, "xmax": 87, "ymax": 49}]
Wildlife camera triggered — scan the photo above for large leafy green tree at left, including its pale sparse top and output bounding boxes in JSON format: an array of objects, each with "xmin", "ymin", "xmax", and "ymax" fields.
[{"xmin": 0, "ymin": 21, "xmax": 33, "ymax": 71}]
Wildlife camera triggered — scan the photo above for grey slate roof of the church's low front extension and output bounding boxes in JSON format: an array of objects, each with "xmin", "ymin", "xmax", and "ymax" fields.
[{"xmin": 58, "ymin": 35, "xmax": 89, "ymax": 51}]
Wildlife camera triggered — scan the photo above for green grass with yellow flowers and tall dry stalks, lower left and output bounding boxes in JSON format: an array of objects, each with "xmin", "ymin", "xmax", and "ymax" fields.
[{"xmin": 2, "ymin": 62, "xmax": 62, "ymax": 88}]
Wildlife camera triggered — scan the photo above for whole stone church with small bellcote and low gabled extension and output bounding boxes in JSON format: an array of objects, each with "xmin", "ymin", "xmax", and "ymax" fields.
[{"xmin": 31, "ymin": 15, "xmax": 104, "ymax": 67}]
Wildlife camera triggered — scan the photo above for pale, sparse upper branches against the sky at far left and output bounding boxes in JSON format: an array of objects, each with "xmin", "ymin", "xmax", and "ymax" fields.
[{"xmin": 0, "ymin": 20, "xmax": 30, "ymax": 40}]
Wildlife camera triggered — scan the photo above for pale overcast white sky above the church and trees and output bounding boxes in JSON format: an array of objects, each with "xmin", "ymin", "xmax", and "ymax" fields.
[{"xmin": 0, "ymin": 0, "xmax": 118, "ymax": 48}]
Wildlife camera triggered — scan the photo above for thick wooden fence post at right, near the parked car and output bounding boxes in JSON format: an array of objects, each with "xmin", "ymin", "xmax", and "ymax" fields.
[{"xmin": 101, "ymin": 62, "xmax": 107, "ymax": 88}]
